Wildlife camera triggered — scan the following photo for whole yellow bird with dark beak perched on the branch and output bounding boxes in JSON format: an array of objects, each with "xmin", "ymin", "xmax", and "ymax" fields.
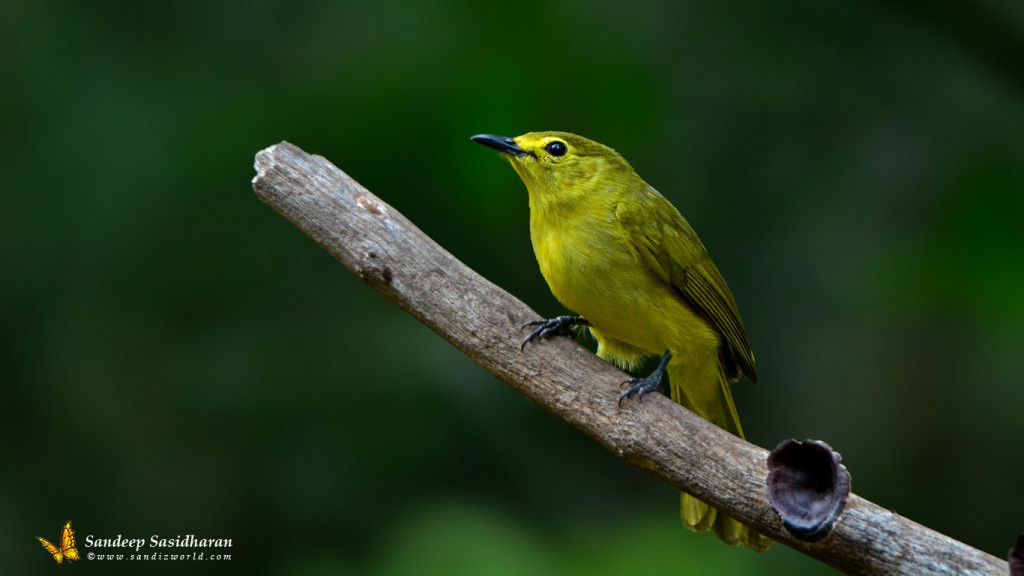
[{"xmin": 472, "ymin": 132, "xmax": 771, "ymax": 551}]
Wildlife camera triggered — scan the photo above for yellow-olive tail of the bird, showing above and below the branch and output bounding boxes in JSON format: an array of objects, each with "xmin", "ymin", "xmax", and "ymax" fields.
[{"xmin": 669, "ymin": 364, "xmax": 772, "ymax": 552}]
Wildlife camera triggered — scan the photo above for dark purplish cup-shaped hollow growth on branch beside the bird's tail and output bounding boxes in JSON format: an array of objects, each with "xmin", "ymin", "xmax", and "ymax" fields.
[{"xmin": 768, "ymin": 440, "xmax": 850, "ymax": 542}]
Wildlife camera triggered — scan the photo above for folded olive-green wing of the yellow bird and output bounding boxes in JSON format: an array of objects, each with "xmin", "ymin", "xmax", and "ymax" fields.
[{"xmin": 615, "ymin": 188, "xmax": 758, "ymax": 382}]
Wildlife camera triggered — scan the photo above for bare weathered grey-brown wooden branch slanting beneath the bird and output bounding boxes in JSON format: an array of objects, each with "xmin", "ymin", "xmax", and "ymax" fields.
[{"xmin": 253, "ymin": 142, "xmax": 1009, "ymax": 575}]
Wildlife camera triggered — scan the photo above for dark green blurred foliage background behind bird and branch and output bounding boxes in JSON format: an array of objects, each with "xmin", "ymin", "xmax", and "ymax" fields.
[{"xmin": 0, "ymin": 0, "xmax": 1024, "ymax": 576}]
